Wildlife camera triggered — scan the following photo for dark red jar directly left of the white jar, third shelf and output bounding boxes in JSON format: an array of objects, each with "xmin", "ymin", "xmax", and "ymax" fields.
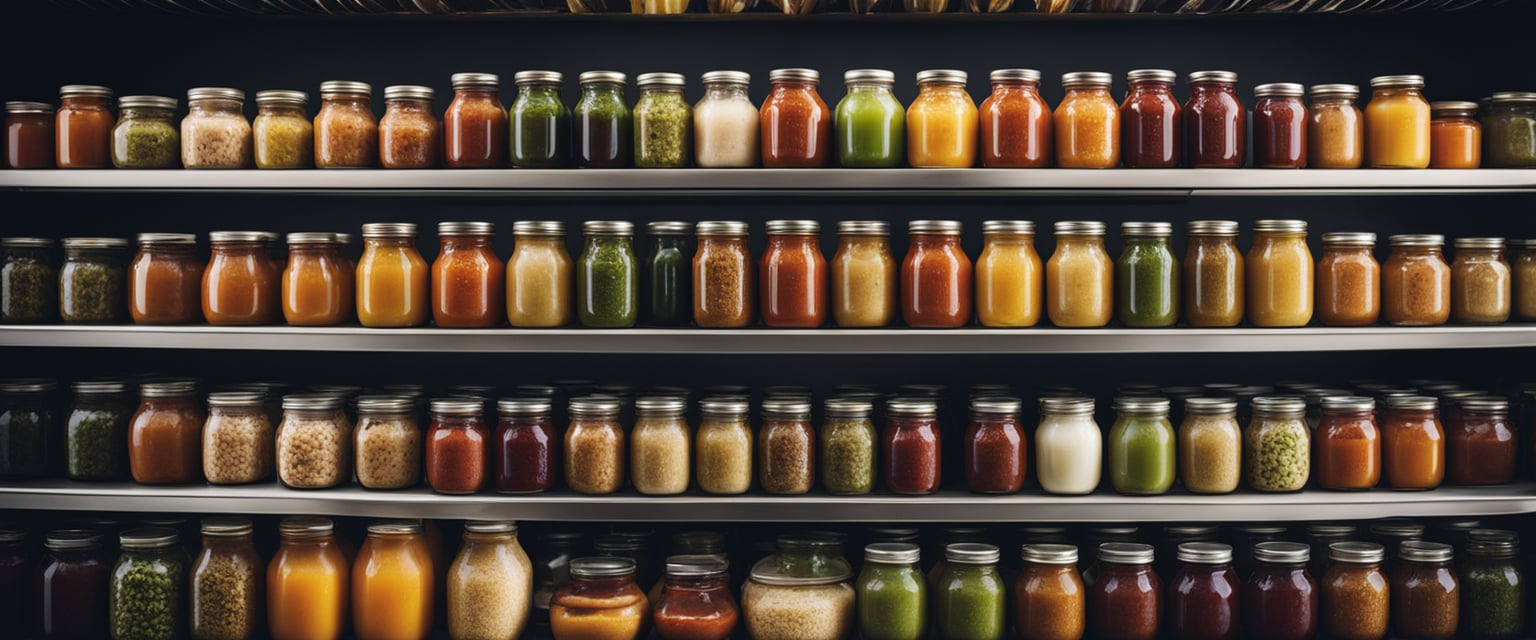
[{"xmin": 965, "ymin": 398, "xmax": 1026, "ymax": 493}]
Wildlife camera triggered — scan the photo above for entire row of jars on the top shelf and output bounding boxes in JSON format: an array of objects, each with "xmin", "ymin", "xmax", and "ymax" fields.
[{"xmin": 6, "ymin": 69, "xmax": 1536, "ymax": 169}]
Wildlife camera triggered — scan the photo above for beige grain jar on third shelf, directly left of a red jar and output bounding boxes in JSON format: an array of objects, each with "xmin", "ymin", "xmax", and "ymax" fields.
[{"xmin": 355, "ymin": 396, "xmax": 422, "ymax": 490}]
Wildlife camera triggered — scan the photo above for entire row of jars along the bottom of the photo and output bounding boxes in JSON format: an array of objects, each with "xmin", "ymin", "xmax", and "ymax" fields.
[{"xmin": 9, "ymin": 517, "xmax": 1528, "ymax": 640}]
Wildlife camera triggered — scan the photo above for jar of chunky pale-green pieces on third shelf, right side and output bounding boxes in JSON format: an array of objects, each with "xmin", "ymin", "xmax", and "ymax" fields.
[{"xmin": 1243, "ymin": 396, "xmax": 1312, "ymax": 491}]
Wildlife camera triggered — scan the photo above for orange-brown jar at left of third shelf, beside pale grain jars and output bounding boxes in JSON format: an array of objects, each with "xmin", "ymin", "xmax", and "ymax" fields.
[{"xmin": 127, "ymin": 381, "xmax": 206, "ymax": 485}]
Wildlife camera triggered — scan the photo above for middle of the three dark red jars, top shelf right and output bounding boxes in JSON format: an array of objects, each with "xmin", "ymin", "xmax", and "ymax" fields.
[{"xmin": 1184, "ymin": 71, "xmax": 1247, "ymax": 169}]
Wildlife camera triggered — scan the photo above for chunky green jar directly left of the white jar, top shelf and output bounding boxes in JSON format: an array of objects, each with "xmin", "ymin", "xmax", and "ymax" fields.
[{"xmin": 634, "ymin": 74, "xmax": 693, "ymax": 169}]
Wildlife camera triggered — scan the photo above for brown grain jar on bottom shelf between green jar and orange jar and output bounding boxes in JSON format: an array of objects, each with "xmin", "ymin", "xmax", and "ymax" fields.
[{"xmin": 187, "ymin": 517, "xmax": 266, "ymax": 640}]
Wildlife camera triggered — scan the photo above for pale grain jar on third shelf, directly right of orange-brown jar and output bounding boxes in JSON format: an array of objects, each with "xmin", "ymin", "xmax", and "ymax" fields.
[{"xmin": 203, "ymin": 391, "xmax": 273, "ymax": 485}]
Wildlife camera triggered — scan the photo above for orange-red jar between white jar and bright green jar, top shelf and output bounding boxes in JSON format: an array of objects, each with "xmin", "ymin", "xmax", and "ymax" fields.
[{"xmin": 759, "ymin": 69, "xmax": 833, "ymax": 169}]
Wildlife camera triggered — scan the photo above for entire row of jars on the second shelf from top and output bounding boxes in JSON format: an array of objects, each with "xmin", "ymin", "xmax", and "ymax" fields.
[{"xmin": 0, "ymin": 219, "xmax": 1536, "ymax": 328}]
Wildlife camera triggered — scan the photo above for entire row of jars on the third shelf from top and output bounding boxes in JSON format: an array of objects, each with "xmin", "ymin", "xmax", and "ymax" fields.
[{"xmin": 0, "ymin": 379, "xmax": 1536, "ymax": 496}]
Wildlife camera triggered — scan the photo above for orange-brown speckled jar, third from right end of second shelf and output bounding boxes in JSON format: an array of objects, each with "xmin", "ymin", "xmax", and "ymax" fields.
[{"xmin": 1381, "ymin": 233, "xmax": 1452, "ymax": 327}]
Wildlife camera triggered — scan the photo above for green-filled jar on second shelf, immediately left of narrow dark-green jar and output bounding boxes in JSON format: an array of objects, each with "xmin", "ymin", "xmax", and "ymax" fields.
[{"xmin": 576, "ymin": 219, "xmax": 641, "ymax": 328}]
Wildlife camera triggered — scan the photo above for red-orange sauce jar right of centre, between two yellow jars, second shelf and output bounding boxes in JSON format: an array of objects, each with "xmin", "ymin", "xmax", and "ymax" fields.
[{"xmin": 902, "ymin": 219, "xmax": 974, "ymax": 328}]
